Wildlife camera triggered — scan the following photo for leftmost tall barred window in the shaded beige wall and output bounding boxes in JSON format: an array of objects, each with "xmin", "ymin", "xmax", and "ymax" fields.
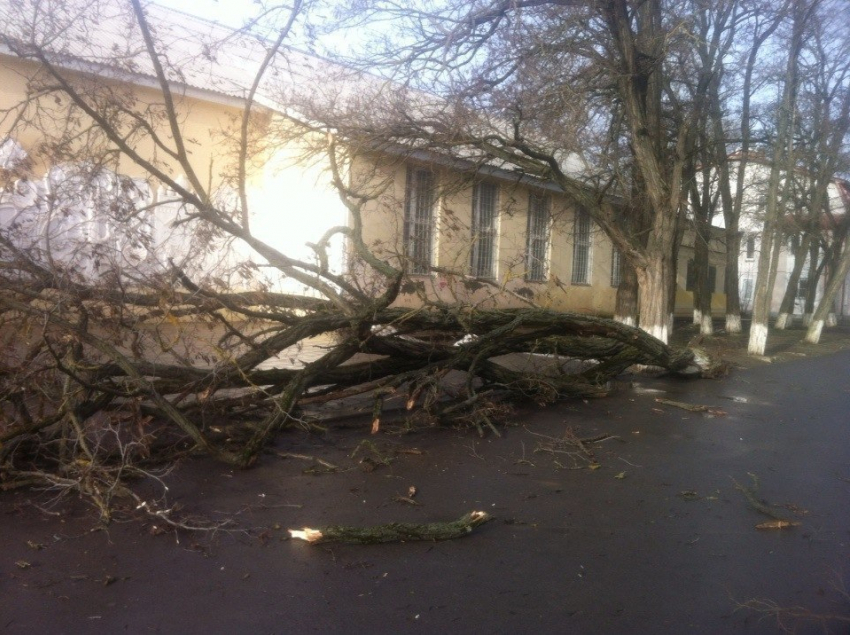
[{"xmin": 404, "ymin": 168, "xmax": 436, "ymax": 274}]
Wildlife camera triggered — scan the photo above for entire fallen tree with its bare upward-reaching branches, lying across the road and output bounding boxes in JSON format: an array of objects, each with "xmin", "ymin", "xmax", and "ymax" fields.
[{"xmin": 0, "ymin": 0, "xmax": 710, "ymax": 518}]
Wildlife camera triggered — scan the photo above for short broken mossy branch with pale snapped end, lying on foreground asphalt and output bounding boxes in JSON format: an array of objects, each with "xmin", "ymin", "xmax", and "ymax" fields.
[{"xmin": 289, "ymin": 511, "xmax": 492, "ymax": 545}]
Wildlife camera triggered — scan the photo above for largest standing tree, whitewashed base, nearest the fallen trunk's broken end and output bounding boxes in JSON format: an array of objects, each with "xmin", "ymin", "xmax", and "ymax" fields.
[{"xmin": 318, "ymin": 0, "xmax": 704, "ymax": 341}]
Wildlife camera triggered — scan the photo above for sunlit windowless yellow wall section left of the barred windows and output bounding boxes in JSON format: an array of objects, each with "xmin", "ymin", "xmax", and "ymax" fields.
[{"xmin": 0, "ymin": 55, "xmax": 347, "ymax": 292}]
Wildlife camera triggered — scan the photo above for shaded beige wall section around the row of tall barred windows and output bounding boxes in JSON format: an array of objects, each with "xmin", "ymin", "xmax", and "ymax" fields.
[{"xmin": 352, "ymin": 156, "xmax": 725, "ymax": 315}]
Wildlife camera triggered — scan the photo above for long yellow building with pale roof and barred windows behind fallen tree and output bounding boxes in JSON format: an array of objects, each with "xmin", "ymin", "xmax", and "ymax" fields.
[{"xmin": 0, "ymin": 1, "xmax": 724, "ymax": 315}]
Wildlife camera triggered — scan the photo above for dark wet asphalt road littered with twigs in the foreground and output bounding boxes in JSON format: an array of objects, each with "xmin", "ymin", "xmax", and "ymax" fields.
[{"xmin": 0, "ymin": 352, "xmax": 850, "ymax": 634}]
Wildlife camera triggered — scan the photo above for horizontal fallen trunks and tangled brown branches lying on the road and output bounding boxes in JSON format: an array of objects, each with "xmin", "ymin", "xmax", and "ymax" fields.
[{"xmin": 0, "ymin": 260, "xmax": 700, "ymax": 504}]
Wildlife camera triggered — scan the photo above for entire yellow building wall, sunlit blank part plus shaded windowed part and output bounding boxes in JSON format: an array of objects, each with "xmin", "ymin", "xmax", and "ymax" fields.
[{"xmin": 0, "ymin": 51, "xmax": 723, "ymax": 315}]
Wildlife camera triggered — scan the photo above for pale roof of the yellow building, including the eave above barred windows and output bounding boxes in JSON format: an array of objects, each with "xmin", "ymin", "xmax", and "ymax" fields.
[{"xmin": 0, "ymin": 0, "xmax": 591, "ymax": 189}]
